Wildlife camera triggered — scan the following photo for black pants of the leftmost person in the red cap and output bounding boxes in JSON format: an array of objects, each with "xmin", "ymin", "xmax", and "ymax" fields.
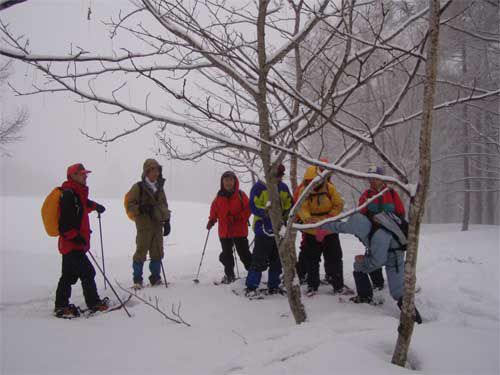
[{"xmin": 56, "ymin": 250, "xmax": 100, "ymax": 308}]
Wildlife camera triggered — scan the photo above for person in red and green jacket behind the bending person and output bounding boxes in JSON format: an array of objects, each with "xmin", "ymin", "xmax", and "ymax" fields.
[{"xmin": 358, "ymin": 166, "xmax": 405, "ymax": 290}]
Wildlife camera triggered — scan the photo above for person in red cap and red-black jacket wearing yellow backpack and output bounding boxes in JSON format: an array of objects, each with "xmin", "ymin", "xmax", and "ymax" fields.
[{"xmin": 54, "ymin": 164, "xmax": 108, "ymax": 318}]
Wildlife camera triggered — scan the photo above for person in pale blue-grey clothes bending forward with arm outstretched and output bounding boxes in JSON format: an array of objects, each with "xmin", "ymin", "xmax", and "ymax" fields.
[{"xmin": 321, "ymin": 213, "xmax": 404, "ymax": 300}]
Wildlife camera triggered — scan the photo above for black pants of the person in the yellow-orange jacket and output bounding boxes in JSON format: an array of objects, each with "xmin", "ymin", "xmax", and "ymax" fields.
[{"xmin": 303, "ymin": 233, "xmax": 344, "ymax": 290}]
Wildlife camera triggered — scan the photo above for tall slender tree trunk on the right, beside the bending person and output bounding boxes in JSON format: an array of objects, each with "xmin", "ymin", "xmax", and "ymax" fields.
[{"xmin": 392, "ymin": 0, "xmax": 440, "ymax": 366}]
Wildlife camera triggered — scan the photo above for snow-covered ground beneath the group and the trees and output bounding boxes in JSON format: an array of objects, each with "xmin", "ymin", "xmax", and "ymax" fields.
[{"xmin": 0, "ymin": 197, "xmax": 500, "ymax": 375}]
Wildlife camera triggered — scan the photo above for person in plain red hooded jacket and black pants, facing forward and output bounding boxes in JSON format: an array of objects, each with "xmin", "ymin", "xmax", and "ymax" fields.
[{"xmin": 207, "ymin": 171, "xmax": 252, "ymax": 284}]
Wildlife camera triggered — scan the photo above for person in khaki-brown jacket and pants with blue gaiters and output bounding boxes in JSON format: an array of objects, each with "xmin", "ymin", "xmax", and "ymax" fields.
[{"xmin": 126, "ymin": 159, "xmax": 170, "ymax": 289}]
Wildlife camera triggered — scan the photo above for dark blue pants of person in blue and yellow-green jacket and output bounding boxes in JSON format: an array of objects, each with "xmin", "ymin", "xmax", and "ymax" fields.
[{"xmin": 246, "ymin": 235, "xmax": 282, "ymax": 289}]
